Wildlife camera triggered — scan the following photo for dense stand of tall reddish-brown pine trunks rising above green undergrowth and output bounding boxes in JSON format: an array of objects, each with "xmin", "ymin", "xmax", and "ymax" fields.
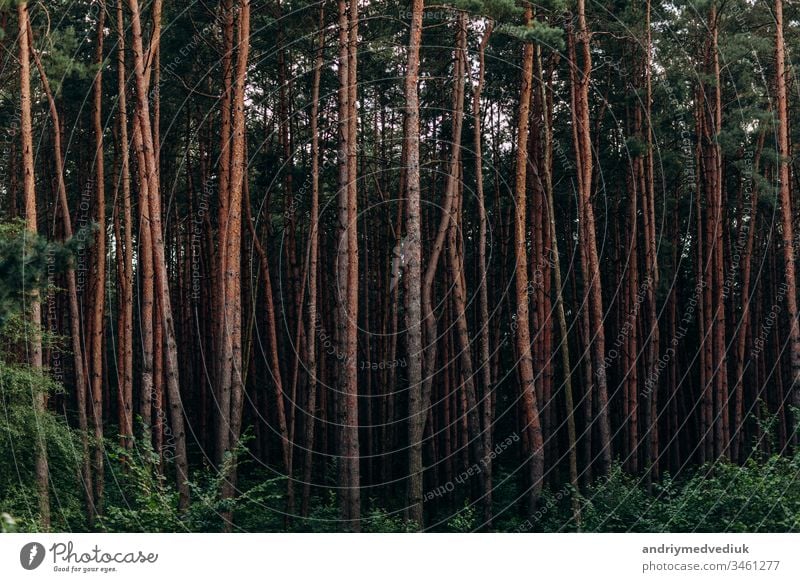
[{"xmin": 7, "ymin": 0, "xmax": 800, "ymax": 531}]
